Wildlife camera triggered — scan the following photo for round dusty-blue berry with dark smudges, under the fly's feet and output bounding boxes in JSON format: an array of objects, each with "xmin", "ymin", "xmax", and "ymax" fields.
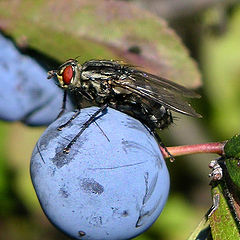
[{"xmin": 31, "ymin": 107, "xmax": 170, "ymax": 240}]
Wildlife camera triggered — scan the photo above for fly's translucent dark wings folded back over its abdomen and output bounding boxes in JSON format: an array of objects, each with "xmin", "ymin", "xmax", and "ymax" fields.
[{"xmin": 114, "ymin": 68, "xmax": 201, "ymax": 117}]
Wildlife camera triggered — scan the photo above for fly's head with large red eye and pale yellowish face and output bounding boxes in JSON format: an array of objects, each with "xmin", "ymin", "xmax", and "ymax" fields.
[{"xmin": 48, "ymin": 59, "xmax": 81, "ymax": 89}]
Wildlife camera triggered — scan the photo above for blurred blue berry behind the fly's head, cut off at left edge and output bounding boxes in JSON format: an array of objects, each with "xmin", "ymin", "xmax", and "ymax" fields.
[{"xmin": 0, "ymin": 35, "xmax": 72, "ymax": 125}]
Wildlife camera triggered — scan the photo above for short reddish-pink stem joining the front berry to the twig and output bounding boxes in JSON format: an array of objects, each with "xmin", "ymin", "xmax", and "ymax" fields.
[{"xmin": 160, "ymin": 142, "xmax": 225, "ymax": 158}]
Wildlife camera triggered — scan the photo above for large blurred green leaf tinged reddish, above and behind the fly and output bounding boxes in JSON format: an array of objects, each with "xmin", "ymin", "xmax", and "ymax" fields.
[{"xmin": 0, "ymin": 0, "xmax": 201, "ymax": 87}]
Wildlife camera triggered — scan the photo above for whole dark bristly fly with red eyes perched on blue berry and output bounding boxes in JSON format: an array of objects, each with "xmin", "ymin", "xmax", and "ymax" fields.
[{"xmin": 48, "ymin": 59, "xmax": 201, "ymax": 153}]
